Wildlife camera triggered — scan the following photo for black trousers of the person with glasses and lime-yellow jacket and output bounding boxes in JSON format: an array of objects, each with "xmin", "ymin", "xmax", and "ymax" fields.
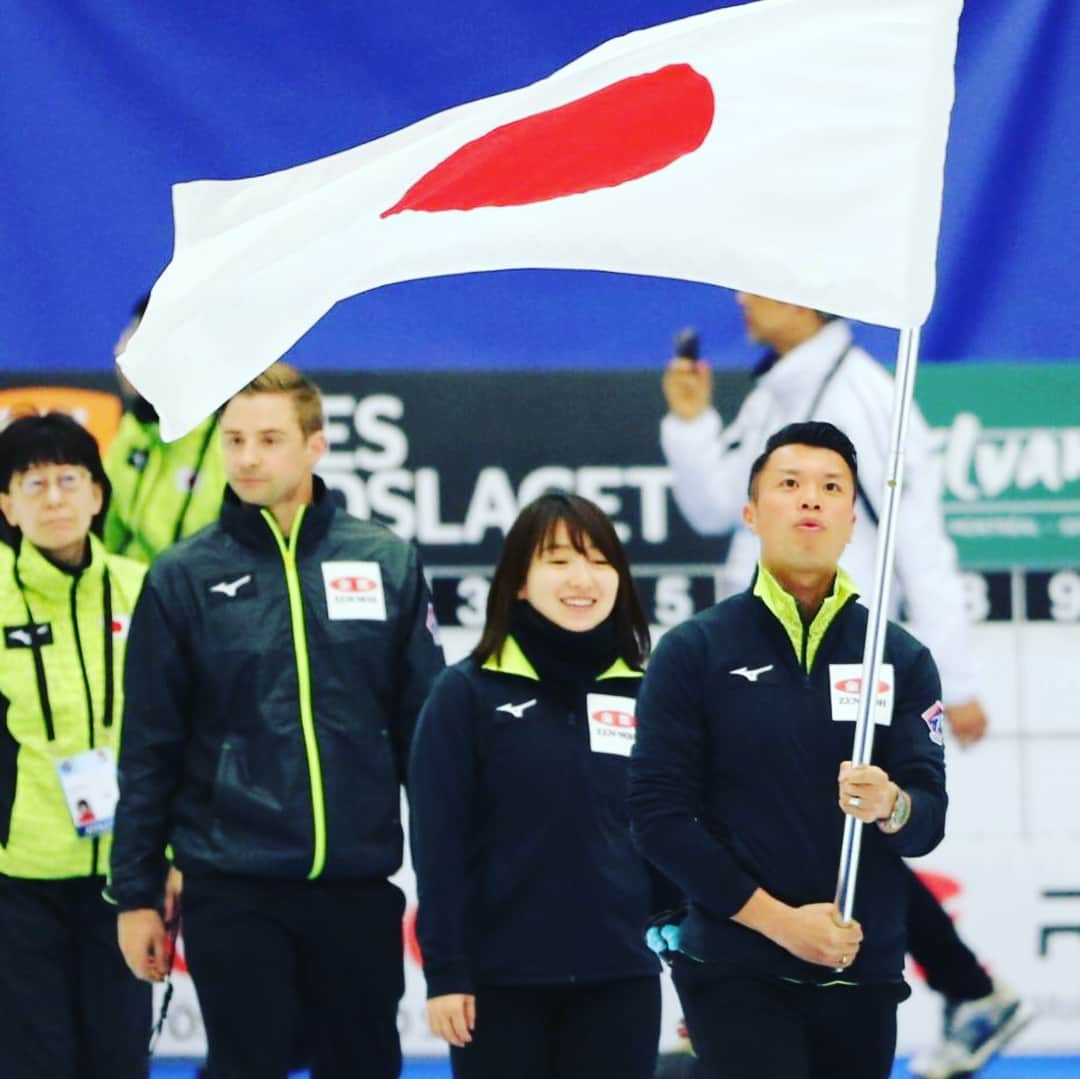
[{"xmin": 0, "ymin": 876, "xmax": 150, "ymax": 1079}]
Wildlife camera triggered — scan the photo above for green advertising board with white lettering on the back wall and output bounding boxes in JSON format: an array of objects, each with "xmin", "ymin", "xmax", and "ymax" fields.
[{"xmin": 916, "ymin": 362, "xmax": 1080, "ymax": 568}]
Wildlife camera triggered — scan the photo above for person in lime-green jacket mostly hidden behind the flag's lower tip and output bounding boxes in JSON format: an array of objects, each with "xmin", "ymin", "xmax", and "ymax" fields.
[{"xmin": 104, "ymin": 296, "xmax": 225, "ymax": 564}]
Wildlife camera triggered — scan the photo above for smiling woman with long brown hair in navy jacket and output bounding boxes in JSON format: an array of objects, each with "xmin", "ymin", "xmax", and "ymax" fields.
[{"xmin": 409, "ymin": 495, "xmax": 671, "ymax": 1079}]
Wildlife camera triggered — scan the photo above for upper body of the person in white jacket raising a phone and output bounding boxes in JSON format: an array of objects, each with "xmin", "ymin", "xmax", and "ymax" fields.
[{"xmin": 660, "ymin": 293, "xmax": 986, "ymax": 743}]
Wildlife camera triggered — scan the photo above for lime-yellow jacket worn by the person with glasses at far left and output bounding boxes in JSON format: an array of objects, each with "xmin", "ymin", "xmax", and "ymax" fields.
[{"xmin": 0, "ymin": 536, "xmax": 146, "ymax": 879}]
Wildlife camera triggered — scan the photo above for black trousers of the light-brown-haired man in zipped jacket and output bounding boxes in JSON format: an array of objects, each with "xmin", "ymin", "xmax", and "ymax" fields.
[{"xmin": 184, "ymin": 876, "xmax": 405, "ymax": 1079}]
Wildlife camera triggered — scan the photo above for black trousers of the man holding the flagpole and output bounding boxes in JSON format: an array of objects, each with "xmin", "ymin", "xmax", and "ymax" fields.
[{"xmin": 672, "ymin": 956, "xmax": 908, "ymax": 1079}]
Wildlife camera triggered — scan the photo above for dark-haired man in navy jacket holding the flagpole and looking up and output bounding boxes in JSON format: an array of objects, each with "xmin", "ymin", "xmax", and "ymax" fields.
[{"xmin": 630, "ymin": 422, "xmax": 947, "ymax": 1079}]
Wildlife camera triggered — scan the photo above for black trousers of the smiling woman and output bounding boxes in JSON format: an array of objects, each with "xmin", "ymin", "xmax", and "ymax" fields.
[{"xmin": 450, "ymin": 977, "xmax": 660, "ymax": 1079}]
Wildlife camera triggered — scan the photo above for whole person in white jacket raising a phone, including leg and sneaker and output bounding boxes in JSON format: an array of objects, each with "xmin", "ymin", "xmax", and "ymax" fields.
[{"xmin": 660, "ymin": 293, "xmax": 1030, "ymax": 1079}]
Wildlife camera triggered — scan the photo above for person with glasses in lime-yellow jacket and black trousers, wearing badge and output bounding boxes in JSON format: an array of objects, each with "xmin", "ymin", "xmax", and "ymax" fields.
[{"xmin": 0, "ymin": 413, "xmax": 150, "ymax": 1079}]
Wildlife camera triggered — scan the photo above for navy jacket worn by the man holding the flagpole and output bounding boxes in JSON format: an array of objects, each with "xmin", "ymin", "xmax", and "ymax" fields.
[{"xmin": 630, "ymin": 591, "xmax": 947, "ymax": 982}]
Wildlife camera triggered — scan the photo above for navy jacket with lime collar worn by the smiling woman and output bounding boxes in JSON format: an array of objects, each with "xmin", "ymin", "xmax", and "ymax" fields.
[{"xmin": 409, "ymin": 638, "xmax": 660, "ymax": 997}]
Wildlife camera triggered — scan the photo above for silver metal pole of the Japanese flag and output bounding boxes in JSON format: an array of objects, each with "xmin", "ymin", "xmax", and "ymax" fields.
[{"xmin": 836, "ymin": 328, "xmax": 921, "ymax": 923}]
